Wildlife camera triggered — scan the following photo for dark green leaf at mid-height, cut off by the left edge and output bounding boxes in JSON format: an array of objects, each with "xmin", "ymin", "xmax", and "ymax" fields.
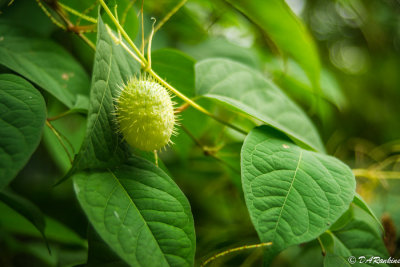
[{"xmin": 0, "ymin": 74, "xmax": 46, "ymax": 190}]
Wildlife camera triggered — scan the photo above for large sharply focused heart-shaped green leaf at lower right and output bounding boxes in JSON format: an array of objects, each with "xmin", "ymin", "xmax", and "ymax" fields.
[{"xmin": 241, "ymin": 126, "xmax": 355, "ymax": 260}]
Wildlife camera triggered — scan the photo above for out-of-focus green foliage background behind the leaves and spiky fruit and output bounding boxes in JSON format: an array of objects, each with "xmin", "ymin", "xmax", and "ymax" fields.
[{"xmin": 0, "ymin": 0, "xmax": 400, "ymax": 266}]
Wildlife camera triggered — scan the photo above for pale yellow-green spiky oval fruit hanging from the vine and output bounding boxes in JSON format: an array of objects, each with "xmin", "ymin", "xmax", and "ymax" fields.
[{"xmin": 116, "ymin": 76, "xmax": 175, "ymax": 151}]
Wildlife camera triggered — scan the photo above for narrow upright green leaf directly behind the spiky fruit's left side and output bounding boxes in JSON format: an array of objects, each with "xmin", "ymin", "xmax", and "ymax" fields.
[{"xmin": 71, "ymin": 16, "xmax": 140, "ymax": 173}]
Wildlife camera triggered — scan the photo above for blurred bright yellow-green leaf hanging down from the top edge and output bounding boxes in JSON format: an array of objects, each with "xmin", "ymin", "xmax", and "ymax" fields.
[{"xmin": 227, "ymin": 0, "xmax": 320, "ymax": 88}]
